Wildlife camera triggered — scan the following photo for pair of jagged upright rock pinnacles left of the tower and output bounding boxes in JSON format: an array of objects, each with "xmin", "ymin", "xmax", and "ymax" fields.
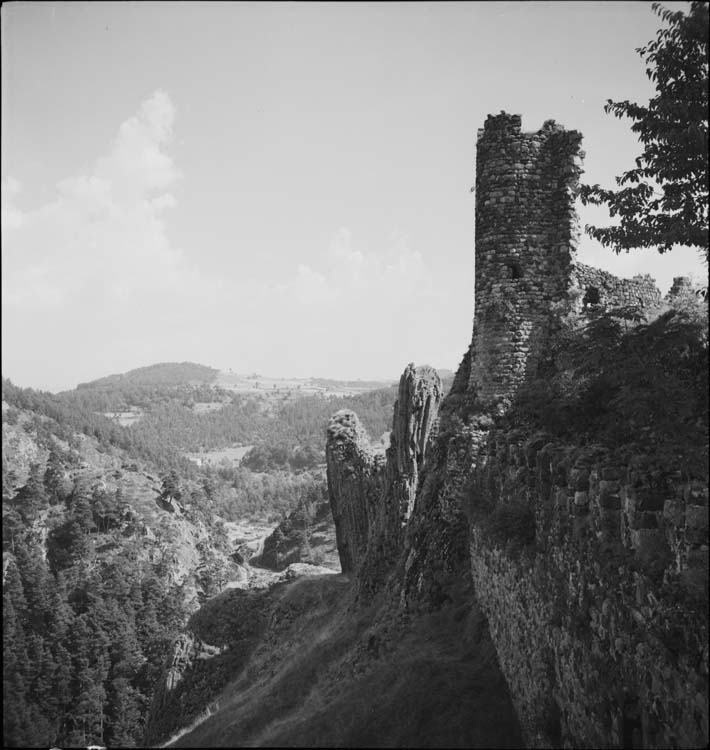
[{"xmin": 326, "ymin": 364, "xmax": 442, "ymax": 593}]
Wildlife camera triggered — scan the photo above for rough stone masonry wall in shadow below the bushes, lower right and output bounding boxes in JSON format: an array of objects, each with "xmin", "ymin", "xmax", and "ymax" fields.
[{"xmin": 470, "ymin": 433, "xmax": 708, "ymax": 748}]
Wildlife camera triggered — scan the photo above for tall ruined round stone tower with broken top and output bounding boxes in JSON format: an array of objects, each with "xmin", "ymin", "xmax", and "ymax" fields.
[{"xmin": 468, "ymin": 112, "xmax": 584, "ymax": 412}]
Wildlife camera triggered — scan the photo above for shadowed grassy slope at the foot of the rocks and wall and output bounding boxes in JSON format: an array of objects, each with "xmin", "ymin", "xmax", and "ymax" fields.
[{"xmin": 170, "ymin": 575, "xmax": 522, "ymax": 747}]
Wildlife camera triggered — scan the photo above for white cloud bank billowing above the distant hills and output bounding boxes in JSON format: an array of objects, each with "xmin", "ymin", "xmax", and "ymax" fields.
[{"xmin": 2, "ymin": 91, "xmax": 450, "ymax": 388}]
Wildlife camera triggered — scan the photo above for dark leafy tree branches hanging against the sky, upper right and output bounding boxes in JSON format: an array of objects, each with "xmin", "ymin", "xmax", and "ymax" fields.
[{"xmin": 581, "ymin": 2, "xmax": 710, "ymax": 260}]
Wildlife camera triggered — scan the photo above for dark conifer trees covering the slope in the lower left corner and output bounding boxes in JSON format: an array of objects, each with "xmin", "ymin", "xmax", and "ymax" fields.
[{"xmin": 3, "ymin": 466, "xmax": 191, "ymax": 747}]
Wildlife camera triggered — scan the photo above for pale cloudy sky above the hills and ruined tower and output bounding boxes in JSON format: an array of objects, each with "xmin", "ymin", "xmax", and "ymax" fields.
[{"xmin": 1, "ymin": 2, "xmax": 707, "ymax": 391}]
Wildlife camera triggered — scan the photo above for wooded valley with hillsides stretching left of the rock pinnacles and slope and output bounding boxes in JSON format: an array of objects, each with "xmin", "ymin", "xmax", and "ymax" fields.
[{"xmin": 2, "ymin": 363, "xmax": 391, "ymax": 746}]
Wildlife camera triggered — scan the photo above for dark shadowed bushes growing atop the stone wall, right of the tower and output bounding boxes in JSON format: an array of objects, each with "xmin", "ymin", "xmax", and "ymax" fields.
[{"xmin": 508, "ymin": 308, "xmax": 708, "ymax": 478}]
